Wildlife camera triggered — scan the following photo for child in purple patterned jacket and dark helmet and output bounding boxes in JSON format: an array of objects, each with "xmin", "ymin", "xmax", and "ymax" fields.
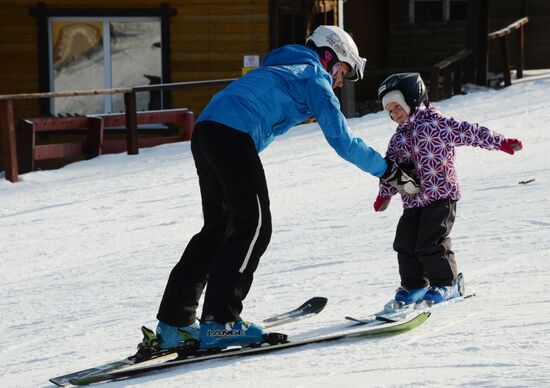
[{"xmin": 374, "ymin": 73, "xmax": 523, "ymax": 310}]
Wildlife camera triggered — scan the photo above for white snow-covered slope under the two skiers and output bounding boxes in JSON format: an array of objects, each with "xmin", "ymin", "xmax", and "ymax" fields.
[{"xmin": 0, "ymin": 72, "xmax": 550, "ymax": 387}]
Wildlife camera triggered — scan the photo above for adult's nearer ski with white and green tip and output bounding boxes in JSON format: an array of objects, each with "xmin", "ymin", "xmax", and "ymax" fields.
[{"xmin": 70, "ymin": 311, "xmax": 431, "ymax": 385}]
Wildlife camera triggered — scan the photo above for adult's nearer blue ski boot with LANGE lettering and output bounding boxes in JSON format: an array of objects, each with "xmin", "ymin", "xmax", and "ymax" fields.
[{"xmin": 199, "ymin": 320, "xmax": 286, "ymax": 350}]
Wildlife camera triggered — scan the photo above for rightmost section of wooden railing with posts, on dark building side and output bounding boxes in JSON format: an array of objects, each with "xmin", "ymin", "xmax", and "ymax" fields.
[{"xmin": 488, "ymin": 17, "xmax": 529, "ymax": 86}]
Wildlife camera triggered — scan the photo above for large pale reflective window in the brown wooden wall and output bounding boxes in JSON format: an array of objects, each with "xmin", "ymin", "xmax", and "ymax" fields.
[{"xmin": 49, "ymin": 18, "xmax": 162, "ymax": 115}]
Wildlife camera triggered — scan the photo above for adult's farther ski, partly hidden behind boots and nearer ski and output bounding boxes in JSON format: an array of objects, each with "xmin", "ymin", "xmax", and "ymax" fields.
[{"xmin": 50, "ymin": 297, "xmax": 328, "ymax": 387}]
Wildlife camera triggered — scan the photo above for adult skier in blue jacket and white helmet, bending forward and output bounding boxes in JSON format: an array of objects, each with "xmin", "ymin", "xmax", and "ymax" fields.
[{"xmin": 153, "ymin": 26, "xmax": 419, "ymax": 349}]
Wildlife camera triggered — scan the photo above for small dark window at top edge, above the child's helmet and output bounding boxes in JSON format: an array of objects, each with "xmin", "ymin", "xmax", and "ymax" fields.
[{"xmin": 409, "ymin": 0, "xmax": 468, "ymax": 23}]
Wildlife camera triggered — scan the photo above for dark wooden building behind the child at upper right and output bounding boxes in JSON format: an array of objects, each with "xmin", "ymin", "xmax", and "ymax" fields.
[{"xmin": 344, "ymin": 0, "xmax": 550, "ymax": 109}]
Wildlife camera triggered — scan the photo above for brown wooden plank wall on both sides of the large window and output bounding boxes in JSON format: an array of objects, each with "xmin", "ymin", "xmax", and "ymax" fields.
[{"xmin": 0, "ymin": 0, "xmax": 269, "ymax": 116}]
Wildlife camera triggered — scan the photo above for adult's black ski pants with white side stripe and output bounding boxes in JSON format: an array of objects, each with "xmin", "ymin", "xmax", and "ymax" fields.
[{"xmin": 157, "ymin": 121, "xmax": 271, "ymax": 327}]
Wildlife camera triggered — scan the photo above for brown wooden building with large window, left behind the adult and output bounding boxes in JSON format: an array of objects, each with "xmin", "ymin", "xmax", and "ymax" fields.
[{"xmin": 0, "ymin": 0, "xmax": 269, "ymax": 116}]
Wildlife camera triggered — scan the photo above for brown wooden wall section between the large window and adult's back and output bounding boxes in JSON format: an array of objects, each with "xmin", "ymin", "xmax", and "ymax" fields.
[{"xmin": 170, "ymin": 0, "xmax": 269, "ymax": 114}]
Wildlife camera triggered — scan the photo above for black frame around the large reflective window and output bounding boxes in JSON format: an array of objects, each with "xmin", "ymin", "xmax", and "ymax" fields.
[{"xmin": 30, "ymin": 2, "xmax": 177, "ymax": 115}]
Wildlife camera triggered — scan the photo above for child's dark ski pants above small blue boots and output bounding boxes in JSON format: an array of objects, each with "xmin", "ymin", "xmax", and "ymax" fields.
[{"xmin": 393, "ymin": 199, "xmax": 457, "ymax": 288}]
